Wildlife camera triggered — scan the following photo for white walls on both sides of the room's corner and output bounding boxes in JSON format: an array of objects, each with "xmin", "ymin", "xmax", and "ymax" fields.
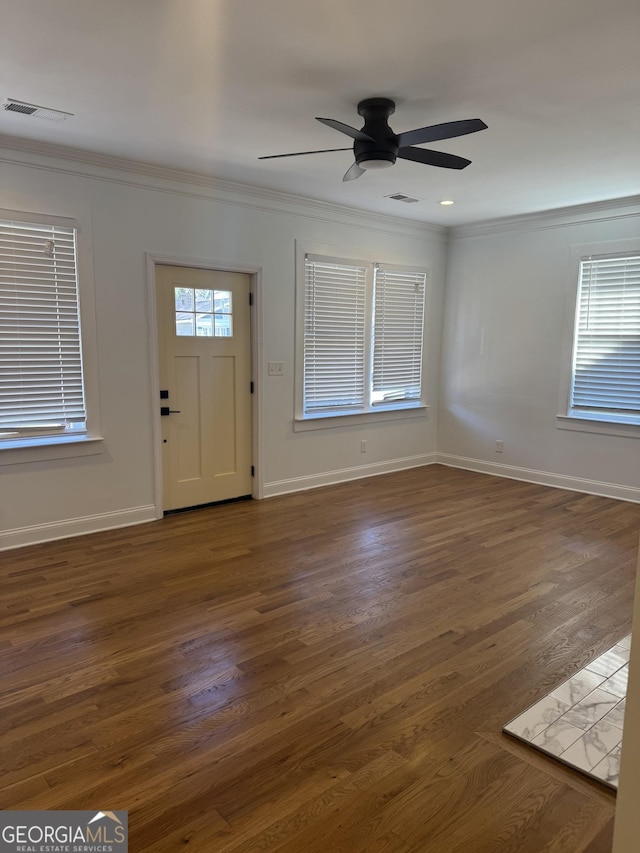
[{"xmin": 0, "ymin": 147, "xmax": 640, "ymax": 548}]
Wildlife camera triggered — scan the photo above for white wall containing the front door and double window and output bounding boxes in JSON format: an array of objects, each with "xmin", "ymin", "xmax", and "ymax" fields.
[{"xmin": 0, "ymin": 148, "xmax": 446, "ymax": 548}]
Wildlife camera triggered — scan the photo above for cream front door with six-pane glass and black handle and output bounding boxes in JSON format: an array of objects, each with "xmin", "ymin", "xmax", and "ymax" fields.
[{"xmin": 156, "ymin": 265, "xmax": 251, "ymax": 510}]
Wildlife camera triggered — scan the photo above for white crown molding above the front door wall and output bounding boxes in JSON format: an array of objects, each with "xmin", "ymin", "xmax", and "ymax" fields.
[{"xmin": 0, "ymin": 135, "xmax": 449, "ymax": 243}]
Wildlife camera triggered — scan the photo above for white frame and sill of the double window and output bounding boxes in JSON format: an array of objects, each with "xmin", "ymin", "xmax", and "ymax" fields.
[{"xmin": 293, "ymin": 243, "xmax": 431, "ymax": 432}]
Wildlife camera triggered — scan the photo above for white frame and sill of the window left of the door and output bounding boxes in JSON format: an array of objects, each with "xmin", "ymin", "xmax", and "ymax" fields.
[{"xmin": 0, "ymin": 208, "xmax": 103, "ymax": 466}]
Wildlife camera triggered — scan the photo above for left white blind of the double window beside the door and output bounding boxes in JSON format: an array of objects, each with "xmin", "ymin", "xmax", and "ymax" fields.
[{"xmin": 304, "ymin": 255, "xmax": 367, "ymax": 414}]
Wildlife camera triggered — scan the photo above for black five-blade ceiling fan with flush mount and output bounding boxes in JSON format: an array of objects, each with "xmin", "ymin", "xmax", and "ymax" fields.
[{"xmin": 258, "ymin": 98, "xmax": 487, "ymax": 181}]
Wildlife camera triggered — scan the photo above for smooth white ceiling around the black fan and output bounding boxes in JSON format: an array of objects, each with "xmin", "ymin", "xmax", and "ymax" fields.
[{"xmin": 0, "ymin": 0, "xmax": 640, "ymax": 224}]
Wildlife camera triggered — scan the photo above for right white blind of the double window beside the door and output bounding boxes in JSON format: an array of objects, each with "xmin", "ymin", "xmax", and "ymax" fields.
[{"xmin": 372, "ymin": 267, "xmax": 426, "ymax": 405}]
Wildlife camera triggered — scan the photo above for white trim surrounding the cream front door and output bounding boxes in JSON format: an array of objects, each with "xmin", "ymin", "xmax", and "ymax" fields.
[{"xmin": 145, "ymin": 252, "xmax": 264, "ymax": 518}]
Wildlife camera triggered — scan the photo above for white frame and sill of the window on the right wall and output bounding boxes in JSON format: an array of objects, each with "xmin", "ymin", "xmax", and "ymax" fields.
[{"xmin": 556, "ymin": 239, "xmax": 640, "ymax": 438}]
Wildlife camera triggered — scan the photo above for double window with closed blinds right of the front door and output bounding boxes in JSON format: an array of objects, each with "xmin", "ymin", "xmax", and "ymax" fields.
[{"xmin": 299, "ymin": 255, "xmax": 426, "ymax": 419}]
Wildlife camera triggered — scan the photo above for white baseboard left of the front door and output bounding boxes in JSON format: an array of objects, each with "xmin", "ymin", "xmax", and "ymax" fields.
[{"xmin": 0, "ymin": 506, "xmax": 158, "ymax": 551}]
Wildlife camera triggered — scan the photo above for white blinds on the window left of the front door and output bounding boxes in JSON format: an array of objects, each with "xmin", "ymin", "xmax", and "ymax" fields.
[{"xmin": 0, "ymin": 220, "xmax": 85, "ymax": 434}]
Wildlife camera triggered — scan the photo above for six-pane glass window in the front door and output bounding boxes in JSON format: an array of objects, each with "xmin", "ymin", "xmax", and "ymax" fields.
[{"xmin": 174, "ymin": 286, "xmax": 233, "ymax": 338}]
